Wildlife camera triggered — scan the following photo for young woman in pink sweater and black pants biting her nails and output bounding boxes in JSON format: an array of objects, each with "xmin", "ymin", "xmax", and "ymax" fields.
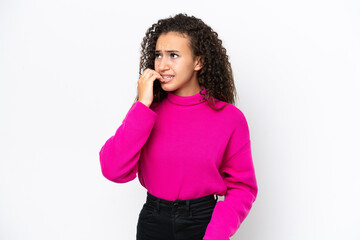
[{"xmin": 100, "ymin": 14, "xmax": 258, "ymax": 240}]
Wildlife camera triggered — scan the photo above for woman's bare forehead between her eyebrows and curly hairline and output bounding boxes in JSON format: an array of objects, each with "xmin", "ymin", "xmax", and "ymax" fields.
[{"xmin": 156, "ymin": 32, "xmax": 191, "ymax": 52}]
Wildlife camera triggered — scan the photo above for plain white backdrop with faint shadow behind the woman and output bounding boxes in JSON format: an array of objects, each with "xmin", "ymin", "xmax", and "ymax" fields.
[{"xmin": 0, "ymin": 0, "xmax": 360, "ymax": 240}]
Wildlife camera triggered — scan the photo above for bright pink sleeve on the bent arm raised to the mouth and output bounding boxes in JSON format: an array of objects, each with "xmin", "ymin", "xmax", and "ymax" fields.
[{"xmin": 99, "ymin": 101, "xmax": 157, "ymax": 183}]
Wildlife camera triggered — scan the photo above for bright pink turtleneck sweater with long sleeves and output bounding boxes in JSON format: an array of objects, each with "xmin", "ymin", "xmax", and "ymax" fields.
[{"xmin": 99, "ymin": 89, "xmax": 258, "ymax": 240}]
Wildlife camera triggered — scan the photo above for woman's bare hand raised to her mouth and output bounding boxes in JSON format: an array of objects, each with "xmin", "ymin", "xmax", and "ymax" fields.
[{"xmin": 138, "ymin": 68, "xmax": 163, "ymax": 107}]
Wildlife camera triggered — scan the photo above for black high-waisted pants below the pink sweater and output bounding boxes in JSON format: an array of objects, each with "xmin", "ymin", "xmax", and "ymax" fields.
[{"xmin": 136, "ymin": 192, "xmax": 217, "ymax": 240}]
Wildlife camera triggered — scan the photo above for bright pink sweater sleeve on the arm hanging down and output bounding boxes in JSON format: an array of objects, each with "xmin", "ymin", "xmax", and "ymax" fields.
[{"xmin": 203, "ymin": 111, "xmax": 258, "ymax": 240}]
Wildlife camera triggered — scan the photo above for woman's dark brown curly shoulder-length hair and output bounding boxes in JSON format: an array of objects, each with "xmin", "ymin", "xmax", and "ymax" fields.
[{"xmin": 135, "ymin": 14, "xmax": 237, "ymax": 110}]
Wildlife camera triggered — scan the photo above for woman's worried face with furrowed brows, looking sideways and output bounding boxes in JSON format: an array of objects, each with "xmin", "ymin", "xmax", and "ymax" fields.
[{"xmin": 155, "ymin": 32, "xmax": 201, "ymax": 96}]
